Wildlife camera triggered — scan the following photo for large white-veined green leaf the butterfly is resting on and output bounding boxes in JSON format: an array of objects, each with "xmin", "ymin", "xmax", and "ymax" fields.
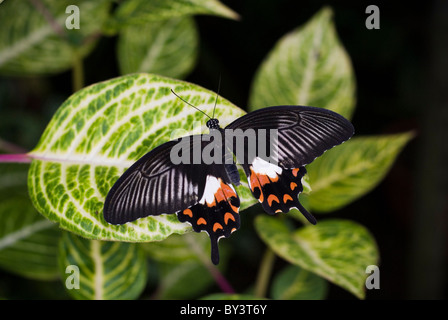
[{"xmin": 28, "ymin": 74, "xmax": 248, "ymax": 241}]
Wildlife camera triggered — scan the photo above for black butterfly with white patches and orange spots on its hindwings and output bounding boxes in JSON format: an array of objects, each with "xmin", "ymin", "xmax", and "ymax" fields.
[{"xmin": 104, "ymin": 95, "xmax": 354, "ymax": 264}]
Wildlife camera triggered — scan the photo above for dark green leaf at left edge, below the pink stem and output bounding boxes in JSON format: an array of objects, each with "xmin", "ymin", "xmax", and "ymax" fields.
[{"xmin": 0, "ymin": 164, "xmax": 60, "ymax": 280}]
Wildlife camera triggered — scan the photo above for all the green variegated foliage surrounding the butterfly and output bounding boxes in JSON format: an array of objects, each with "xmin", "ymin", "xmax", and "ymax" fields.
[{"xmin": 0, "ymin": 0, "xmax": 412, "ymax": 299}]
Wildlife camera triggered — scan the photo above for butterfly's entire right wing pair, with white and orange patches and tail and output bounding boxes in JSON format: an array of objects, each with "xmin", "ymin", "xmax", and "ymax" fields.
[{"xmin": 226, "ymin": 106, "xmax": 354, "ymax": 224}]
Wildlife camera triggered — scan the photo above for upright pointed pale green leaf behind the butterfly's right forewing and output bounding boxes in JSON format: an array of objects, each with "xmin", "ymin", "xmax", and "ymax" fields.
[{"xmin": 249, "ymin": 8, "xmax": 355, "ymax": 118}]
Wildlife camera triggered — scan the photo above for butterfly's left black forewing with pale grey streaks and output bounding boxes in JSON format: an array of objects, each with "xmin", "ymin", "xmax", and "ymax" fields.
[{"xmin": 104, "ymin": 136, "xmax": 206, "ymax": 224}]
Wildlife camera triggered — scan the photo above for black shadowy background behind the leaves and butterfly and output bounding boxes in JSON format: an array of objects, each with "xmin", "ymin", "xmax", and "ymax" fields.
[{"xmin": 0, "ymin": 0, "xmax": 448, "ymax": 299}]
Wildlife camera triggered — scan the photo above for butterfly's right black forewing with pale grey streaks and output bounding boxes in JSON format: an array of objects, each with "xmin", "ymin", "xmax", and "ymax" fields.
[{"xmin": 226, "ymin": 106, "xmax": 354, "ymax": 169}]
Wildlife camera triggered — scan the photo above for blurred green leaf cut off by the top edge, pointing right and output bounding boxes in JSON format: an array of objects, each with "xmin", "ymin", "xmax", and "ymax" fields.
[{"xmin": 111, "ymin": 0, "xmax": 238, "ymax": 28}]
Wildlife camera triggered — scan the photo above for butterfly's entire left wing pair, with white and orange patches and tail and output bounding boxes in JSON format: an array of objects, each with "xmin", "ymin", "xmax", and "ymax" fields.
[{"xmin": 103, "ymin": 135, "xmax": 240, "ymax": 264}]
